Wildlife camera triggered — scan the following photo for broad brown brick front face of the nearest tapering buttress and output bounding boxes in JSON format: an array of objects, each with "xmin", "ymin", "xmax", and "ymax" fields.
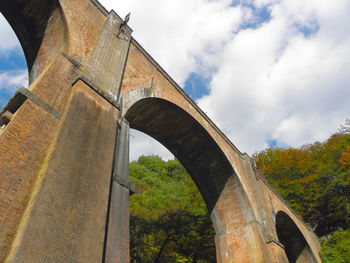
[{"xmin": 3, "ymin": 81, "xmax": 119, "ymax": 263}]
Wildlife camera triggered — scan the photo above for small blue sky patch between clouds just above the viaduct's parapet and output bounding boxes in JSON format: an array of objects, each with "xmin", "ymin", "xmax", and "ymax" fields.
[{"xmin": 184, "ymin": 72, "xmax": 210, "ymax": 100}]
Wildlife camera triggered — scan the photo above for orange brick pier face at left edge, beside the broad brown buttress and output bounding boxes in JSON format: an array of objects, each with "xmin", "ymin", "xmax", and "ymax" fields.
[{"xmin": 0, "ymin": 101, "xmax": 57, "ymax": 262}]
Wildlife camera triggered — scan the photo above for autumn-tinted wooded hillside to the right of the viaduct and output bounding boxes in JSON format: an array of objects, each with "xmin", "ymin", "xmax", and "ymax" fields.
[{"xmin": 253, "ymin": 120, "xmax": 350, "ymax": 263}]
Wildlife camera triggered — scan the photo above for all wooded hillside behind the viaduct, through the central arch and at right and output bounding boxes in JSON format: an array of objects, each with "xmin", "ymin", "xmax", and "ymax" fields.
[{"xmin": 130, "ymin": 121, "xmax": 350, "ymax": 263}]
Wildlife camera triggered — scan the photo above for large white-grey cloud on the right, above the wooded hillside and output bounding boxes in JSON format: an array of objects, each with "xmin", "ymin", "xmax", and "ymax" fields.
[{"xmin": 199, "ymin": 1, "xmax": 350, "ymax": 153}]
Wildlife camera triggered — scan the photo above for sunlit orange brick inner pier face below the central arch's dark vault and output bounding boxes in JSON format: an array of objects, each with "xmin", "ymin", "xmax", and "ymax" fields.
[{"xmin": 211, "ymin": 176, "xmax": 271, "ymax": 263}]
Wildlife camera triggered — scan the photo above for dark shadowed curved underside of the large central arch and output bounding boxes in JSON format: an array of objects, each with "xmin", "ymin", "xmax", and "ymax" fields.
[{"xmin": 124, "ymin": 97, "xmax": 235, "ymax": 212}]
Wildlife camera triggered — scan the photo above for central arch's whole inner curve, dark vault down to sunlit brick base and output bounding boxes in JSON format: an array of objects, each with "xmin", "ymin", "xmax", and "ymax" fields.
[{"xmin": 123, "ymin": 97, "xmax": 269, "ymax": 262}]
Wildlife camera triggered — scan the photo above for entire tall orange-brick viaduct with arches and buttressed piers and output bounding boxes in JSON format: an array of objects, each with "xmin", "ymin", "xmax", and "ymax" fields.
[{"xmin": 0, "ymin": 0, "xmax": 321, "ymax": 263}]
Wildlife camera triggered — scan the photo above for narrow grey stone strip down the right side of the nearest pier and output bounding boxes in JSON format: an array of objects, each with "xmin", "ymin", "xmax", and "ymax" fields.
[{"xmin": 105, "ymin": 120, "xmax": 134, "ymax": 263}]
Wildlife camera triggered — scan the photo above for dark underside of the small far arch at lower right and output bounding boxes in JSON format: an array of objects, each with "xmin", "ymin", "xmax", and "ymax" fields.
[{"xmin": 276, "ymin": 211, "xmax": 317, "ymax": 263}]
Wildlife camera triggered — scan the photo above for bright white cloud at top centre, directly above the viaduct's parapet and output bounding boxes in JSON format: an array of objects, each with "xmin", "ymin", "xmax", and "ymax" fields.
[{"xmin": 101, "ymin": 0, "xmax": 246, "ymax": 85}]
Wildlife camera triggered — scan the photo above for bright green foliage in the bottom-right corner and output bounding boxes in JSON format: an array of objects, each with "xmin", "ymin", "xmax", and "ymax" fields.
[{"xmin": 321, "ymin": 230, "xmax": 350, "ymax": 263}]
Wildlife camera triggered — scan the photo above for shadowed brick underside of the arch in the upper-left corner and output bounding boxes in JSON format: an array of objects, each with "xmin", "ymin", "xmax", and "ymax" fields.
[{"xmin": 0, "ymin": 0, "xmax": 67, "ymax": 83}]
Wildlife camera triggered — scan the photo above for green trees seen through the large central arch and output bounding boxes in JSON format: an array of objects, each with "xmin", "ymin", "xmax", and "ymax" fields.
[{"xmin": 130, "ymin": 156, "xmax": 215, "ymax": 263}]
